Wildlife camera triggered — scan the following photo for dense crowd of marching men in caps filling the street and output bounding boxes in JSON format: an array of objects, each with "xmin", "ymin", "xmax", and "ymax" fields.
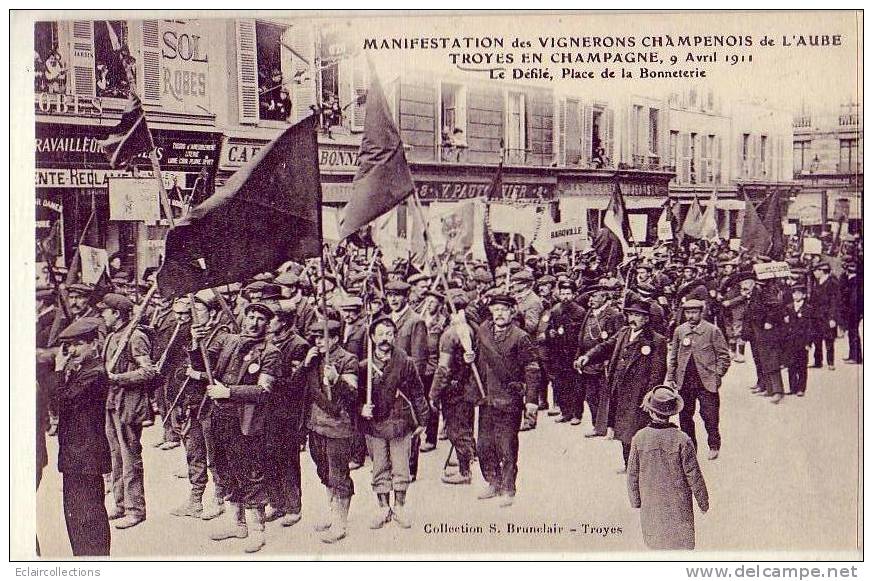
[{"xmin": 37, "ymin": 230, "xmax": 863, "ymax": 555}]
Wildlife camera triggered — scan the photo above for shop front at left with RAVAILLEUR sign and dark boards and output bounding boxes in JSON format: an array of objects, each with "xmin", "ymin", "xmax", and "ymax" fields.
[{"xmin": 34, "ymin": 121, "xmax": 221, "ymax": 277}]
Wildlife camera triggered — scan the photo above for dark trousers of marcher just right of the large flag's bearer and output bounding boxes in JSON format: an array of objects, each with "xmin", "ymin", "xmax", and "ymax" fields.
[{"xmin": 264, "ymin": 421, "xmax": 301, "ymax": 514}]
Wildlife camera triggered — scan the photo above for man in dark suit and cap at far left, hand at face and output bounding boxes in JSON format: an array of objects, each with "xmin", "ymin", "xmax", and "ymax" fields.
[{"xmin": 56, "ymin": 317, "xmax": 112, "ymax": 557}]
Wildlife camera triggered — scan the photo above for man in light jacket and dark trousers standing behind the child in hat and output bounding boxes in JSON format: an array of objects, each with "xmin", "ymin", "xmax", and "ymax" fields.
[{"xmin": 667, "ymin": 299, "xmax": 731, "ymax": 460}]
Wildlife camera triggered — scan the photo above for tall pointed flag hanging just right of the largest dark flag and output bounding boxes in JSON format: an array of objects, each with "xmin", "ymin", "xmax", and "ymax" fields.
[{"xmin": 340, "ymin": 61, "xmax": 415, "ymax": 238}]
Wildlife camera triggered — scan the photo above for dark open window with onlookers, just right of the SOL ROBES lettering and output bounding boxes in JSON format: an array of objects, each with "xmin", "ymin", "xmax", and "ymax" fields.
[{"xmin": 255, "ymin": 21, "xmax": 291, "ymax": 121}]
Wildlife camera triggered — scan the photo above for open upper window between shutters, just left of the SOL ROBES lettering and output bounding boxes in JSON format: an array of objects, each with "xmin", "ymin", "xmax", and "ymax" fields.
[{"xmin": 94, "ymin": 20, "xmax": 136, "ymax": 99}]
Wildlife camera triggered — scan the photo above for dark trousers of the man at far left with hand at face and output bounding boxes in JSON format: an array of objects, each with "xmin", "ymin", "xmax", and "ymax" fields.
[{"xmin": 63, "ymin": 472, "xmax": 111, "ymax": 557}]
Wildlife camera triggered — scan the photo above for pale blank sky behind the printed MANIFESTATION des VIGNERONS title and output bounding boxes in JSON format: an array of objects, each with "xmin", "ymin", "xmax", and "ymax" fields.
[{"xmin": 314, "ymin": 11, "xmax": 863, "ymax": 111}]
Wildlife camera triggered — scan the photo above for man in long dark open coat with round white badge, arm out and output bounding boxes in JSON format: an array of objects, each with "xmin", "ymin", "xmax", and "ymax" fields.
[{"xmin": 576, "ymin": 299, "xmax": 667, "ymax": 473}]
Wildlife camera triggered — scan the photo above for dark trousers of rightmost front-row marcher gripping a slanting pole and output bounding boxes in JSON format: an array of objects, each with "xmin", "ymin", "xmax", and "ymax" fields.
[{"xmin": 478, "ymin": 406, "xmax": 522, "ymax": 494}]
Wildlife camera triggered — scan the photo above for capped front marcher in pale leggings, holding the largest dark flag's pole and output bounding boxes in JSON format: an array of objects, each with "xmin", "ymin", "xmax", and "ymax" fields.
[{"xmin": 187, "ymin": 303, "xmax": 281, "ymax": 553}]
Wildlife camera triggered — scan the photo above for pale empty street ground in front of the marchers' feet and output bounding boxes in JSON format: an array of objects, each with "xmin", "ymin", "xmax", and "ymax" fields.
[{"xmin": 37, "ymin": 339, "xmax": 862, "ymax": 559}]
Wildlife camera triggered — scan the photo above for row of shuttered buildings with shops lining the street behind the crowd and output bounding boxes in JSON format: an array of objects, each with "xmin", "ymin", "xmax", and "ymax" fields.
[{"xmin": 34, "ymin": 18, "xmax": 808, "ymax": 277}]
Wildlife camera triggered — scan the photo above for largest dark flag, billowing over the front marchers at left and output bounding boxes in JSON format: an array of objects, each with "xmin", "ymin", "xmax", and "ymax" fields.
[{"xmin": 158, "ymin": 115, "xmax": 322, "ymax": 297}]
